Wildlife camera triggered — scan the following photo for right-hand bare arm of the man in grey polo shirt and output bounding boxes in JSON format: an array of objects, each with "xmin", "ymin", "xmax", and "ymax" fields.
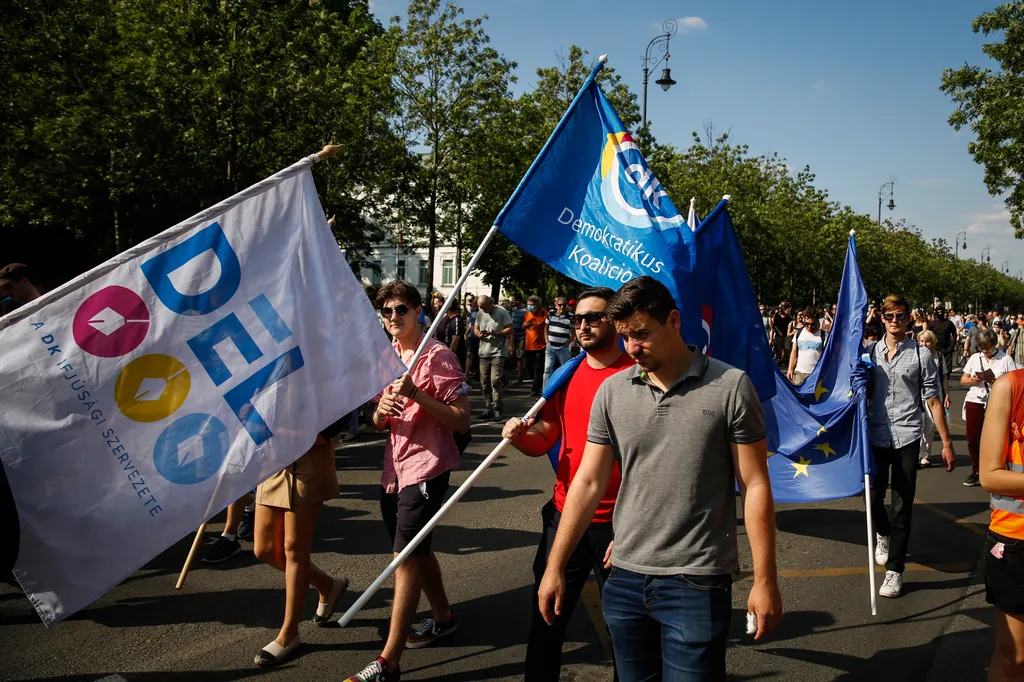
[{"xmin": 733, "ymin": 438, "xmax": 782, "ymax": 639}]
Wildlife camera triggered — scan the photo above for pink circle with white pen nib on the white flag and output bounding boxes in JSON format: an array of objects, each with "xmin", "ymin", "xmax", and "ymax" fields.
[{"xmin": 72, "ymin": 287, "xmax": 150, "ymax": 357}]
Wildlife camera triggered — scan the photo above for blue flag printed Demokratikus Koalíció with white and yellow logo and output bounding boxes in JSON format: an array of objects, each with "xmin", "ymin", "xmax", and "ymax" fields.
[{"xmin": 495, "ymin": 58, "xmax": 700, "ymax": 346}]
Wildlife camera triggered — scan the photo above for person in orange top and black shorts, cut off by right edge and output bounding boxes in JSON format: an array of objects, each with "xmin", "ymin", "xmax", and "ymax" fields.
[{"xmin": 979, "ymin": 370, "xmax": 1024, "ymax": 682}]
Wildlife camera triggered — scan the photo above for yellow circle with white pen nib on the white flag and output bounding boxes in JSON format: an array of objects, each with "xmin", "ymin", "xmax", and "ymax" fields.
[{"xmin": 114, "ymin": 353, "xmax": 191, "ymax": 422}]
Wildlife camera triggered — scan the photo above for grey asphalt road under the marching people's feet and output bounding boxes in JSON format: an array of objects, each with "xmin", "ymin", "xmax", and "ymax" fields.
[{"xmin": 0, "ymin": 366, "xmax": 992, "ymax": 682}]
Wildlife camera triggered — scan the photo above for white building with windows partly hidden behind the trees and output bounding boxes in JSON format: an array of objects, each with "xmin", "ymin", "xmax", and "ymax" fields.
[{"xmin": 359, "ymin": 244, "xmax": 499, "ymax": 301}]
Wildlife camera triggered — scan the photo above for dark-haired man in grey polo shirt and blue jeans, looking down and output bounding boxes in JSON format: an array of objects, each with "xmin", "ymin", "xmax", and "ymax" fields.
[{"xmin": 538, "ymin": 276, "xmax": 782, "ymax": 680}]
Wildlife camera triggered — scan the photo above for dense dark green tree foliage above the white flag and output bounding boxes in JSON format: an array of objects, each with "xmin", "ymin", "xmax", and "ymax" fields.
[{"xmin": 0, "ymin": 0, "xmax": 409, "ymax": 281}]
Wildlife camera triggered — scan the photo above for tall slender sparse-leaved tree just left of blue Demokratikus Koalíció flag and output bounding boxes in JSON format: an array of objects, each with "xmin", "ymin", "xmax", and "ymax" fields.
[{"xmin": 392, "ymin": 0, "xmax": 515, "ymax": 295}]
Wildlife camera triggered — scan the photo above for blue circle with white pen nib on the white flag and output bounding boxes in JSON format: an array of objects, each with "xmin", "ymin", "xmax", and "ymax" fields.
[{"xmin": 153, "ymin": 413, "xmax": 230, "ymax": 485}]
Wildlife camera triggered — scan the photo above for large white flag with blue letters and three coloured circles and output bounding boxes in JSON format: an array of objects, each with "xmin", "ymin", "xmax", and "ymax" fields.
[{"xmin": 0, "ymin": 160, "xmax": 404, "ymax": 627}]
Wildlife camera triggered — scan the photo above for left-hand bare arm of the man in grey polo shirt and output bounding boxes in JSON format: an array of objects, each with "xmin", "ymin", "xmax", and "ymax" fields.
[{"xmin": 538, "ymin": 442, "xmax": 615, "ymax": 625}]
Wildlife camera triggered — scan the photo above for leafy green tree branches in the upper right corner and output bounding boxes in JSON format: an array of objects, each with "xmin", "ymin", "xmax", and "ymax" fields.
[{"xmin": 941, "ymin": 2, "xmax": 1024, "ymax": 233}]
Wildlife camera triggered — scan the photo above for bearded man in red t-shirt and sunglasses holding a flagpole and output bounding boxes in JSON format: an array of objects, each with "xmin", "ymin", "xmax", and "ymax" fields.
[{"xmin": 502, "ymin": 287, "xmax": 633, "ymax": 682}]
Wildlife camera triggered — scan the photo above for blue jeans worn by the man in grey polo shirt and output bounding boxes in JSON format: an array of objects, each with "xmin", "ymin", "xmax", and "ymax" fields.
[{"xmin": 601, "ymin": 567, "xmax": 732, "ymax": 682}]
